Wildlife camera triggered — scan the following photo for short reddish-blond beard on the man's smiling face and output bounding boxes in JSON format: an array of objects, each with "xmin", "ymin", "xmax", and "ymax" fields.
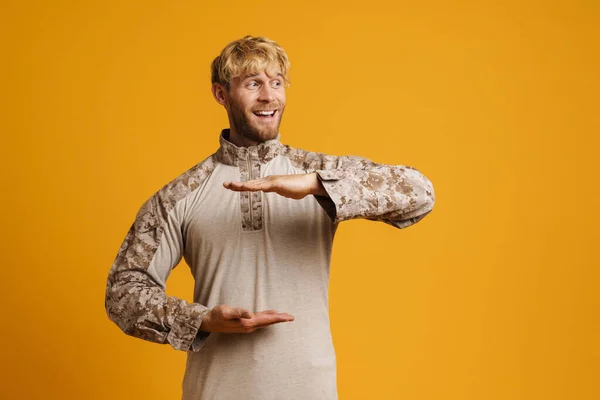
[{"xmin": 230, "ymin": 102, "xmax": 285, "ymax": 142}]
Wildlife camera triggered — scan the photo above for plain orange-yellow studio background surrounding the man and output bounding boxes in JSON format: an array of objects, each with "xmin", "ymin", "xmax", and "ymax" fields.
[{"xmin": 0, "ymin": 0, "xmax": 600, "ymax": 400}]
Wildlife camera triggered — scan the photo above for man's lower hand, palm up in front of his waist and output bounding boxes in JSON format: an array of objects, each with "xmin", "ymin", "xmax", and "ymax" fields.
[{"xmin": 200, "ymin": 304, "xmax": 294, "ymax": 333}]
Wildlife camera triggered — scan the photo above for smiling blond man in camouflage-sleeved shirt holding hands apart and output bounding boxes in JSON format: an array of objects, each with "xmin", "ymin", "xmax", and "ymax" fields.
[{"xmin": 106, "ymin": 36, "xmax": 435, "ymax": 400}]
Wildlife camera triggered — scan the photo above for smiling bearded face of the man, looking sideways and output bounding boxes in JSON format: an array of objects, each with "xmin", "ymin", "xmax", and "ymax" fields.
[{"xmin": 225, "ymin": 69, "xmax": 285, "ymax": 142}]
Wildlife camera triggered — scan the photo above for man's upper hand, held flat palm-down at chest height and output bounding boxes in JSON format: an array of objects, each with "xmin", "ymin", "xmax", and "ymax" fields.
[{"xmin": 223, "ymin": 172, "xmax": 329, "ymax": 200}]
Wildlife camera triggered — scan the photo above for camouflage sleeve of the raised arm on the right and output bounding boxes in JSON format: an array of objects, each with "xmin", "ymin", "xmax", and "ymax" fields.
[{"xmin": 315, "ymin": 156, "xmax": 435, "ymax": 228}]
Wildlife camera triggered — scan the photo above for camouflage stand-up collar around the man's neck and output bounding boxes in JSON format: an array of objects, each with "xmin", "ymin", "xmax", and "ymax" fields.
[{"xmin": 216, "ymin": 128, "xmax": 284, "ymax": 166}]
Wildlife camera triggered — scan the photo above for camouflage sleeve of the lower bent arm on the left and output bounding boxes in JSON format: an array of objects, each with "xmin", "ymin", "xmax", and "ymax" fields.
[{"xmin": 105, "ymin": 192, "xmax": 209, "ymax": 351}]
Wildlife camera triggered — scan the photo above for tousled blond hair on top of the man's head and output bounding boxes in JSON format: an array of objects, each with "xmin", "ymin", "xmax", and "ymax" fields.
[{"xmin": 210, "ymin": 35, "xmax": 290, "ymax": 89}]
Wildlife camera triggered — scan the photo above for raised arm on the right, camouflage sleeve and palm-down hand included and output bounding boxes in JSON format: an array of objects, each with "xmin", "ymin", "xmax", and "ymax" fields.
[{"xmin": 223, "ymin": 153, "xmax": 435, "ymax": 228}]
